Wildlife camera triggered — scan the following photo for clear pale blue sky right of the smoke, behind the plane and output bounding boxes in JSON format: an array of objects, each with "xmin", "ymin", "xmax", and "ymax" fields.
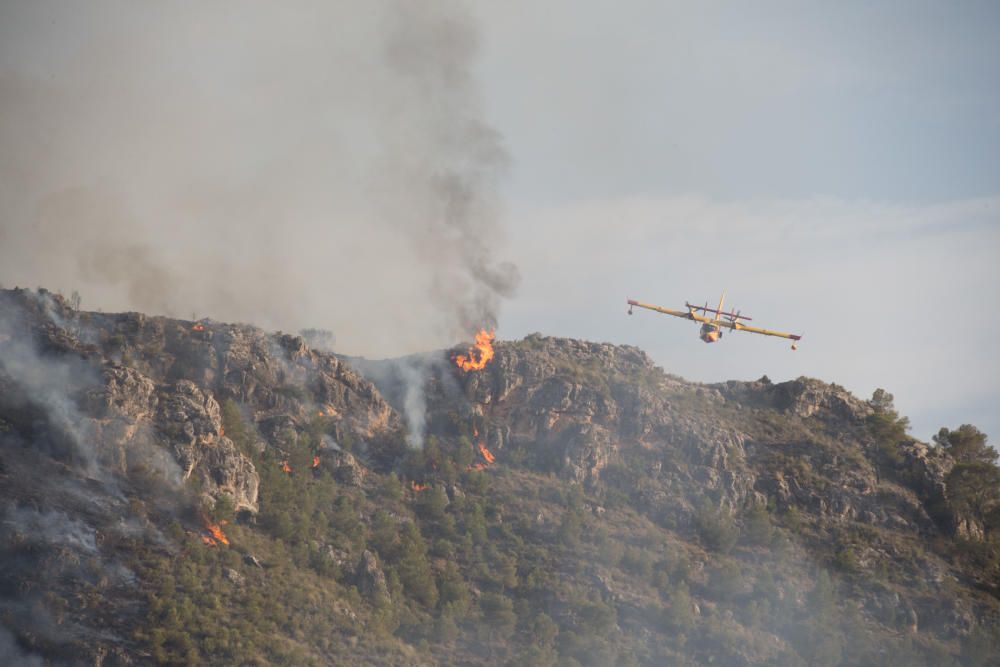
[{"xmin": 470, "ymin": 2, "xmax": 1000, "ymax": 439}]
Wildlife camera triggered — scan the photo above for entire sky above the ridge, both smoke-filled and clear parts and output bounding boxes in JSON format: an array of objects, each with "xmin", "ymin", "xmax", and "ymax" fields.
[{"xmin": 0, "ymin": 0, "xmax": 1000, "ymax": 440}]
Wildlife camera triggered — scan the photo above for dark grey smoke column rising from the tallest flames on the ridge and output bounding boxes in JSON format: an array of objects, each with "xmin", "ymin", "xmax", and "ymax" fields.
[{"xmin": 374, "ymin": 3, "xmax": 520, "ymax": 338}]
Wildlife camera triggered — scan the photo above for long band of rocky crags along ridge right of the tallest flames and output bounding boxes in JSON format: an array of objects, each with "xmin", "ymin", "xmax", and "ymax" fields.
[{"xmin": 416, "ymin": 335, "xmax": 978, "ymax": 536}]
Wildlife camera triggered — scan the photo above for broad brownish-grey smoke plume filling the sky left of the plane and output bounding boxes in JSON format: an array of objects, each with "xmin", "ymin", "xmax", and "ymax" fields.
[{"xmin": 0, "ymin": 0, "xmax": 518, "ymax": 356}]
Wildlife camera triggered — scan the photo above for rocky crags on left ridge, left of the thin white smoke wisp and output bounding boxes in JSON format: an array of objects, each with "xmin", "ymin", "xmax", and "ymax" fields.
[{"xmin": 0, "ymin": 290, "xmax": 400, "ymax": 511}]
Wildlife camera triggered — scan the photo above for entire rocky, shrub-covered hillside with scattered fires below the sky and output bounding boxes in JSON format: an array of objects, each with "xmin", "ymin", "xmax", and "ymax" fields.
[{"xmin": 0, "ymin": 290, "xmax": 1000, "ymax": 665}]
